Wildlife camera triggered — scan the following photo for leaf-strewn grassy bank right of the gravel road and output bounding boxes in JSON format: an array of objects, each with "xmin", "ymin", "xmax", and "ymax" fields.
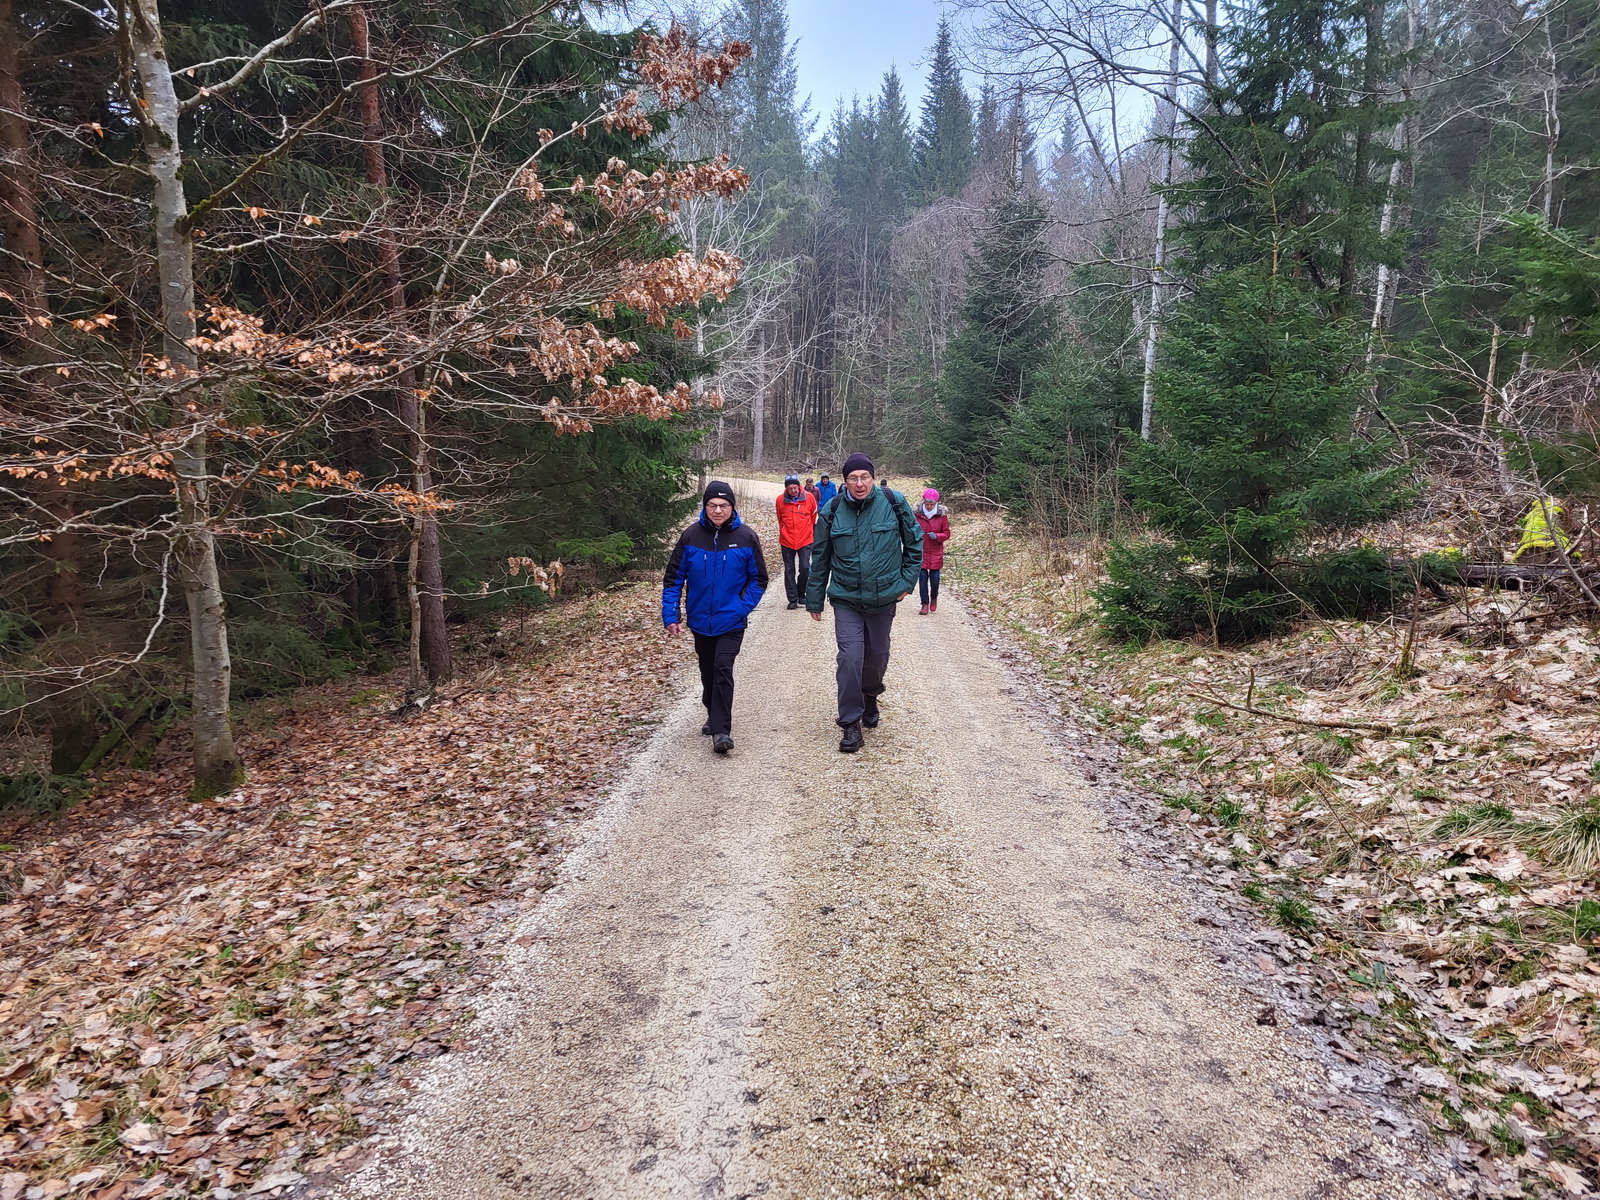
[{"xmin": 962, "ymin": 517, "xmax": 1600, "ymax": 1195}]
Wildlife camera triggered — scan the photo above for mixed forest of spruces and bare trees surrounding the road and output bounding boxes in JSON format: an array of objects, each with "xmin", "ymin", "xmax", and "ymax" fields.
[{"xmin": 0, "ymin": 0, "xmax": 1600, "ymax": 794}]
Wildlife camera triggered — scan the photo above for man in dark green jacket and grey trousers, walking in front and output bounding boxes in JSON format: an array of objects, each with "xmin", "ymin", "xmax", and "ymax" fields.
[{"xmin": 805, "ymin": 453, "xmax": 922, "ymax": 754}]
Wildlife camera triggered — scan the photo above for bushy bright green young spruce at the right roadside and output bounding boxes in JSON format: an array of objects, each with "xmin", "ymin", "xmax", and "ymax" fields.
[{"xmin": 1099, "ymin": 264, "xmax": 1405, "ymax": 642}]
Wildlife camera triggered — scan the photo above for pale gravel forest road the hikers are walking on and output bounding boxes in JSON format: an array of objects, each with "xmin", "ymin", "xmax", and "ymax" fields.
[{"xmin": 331, "ymin": 482, "xmax": 1445, "ymax": 1200}]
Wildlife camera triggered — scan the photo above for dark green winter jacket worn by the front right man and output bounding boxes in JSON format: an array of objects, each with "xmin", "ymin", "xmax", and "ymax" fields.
[{"xmin": 805, "ymin": 486, "xmax": 922, "ymax": 616}]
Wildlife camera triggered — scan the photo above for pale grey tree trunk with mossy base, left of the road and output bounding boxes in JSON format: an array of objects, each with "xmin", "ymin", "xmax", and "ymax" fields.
[{"xmin": 125, "ymin": 0, "xmax": 245, "ymax": 797}]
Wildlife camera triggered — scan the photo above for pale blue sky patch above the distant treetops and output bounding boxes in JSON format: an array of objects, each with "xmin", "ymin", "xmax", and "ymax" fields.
[{"xmin": 789, "ymin": 0, "xmax": 941, "ymax": 125}]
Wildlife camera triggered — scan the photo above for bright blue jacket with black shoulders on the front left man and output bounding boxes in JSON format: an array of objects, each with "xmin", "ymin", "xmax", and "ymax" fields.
[{"xmin": 661, "ymin": 507, "xmax": 766, "ymax": 637}]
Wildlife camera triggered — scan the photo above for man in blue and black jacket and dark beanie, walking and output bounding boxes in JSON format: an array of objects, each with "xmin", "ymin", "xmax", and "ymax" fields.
[{"xmin": 661, "ymin": 480, "xmax": 766, "ymax": 754}]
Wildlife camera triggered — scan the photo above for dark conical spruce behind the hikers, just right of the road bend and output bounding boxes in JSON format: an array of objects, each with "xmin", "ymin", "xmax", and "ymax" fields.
[{"xmin": 933, "ymin": 189, "xmax": 1058, "ymax": 491}]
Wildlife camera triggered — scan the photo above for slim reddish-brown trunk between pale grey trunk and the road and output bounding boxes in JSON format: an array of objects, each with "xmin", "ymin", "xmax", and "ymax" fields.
[{"xmin": 350, "ymin": 5, "xmax": 454, "ymax": 699}]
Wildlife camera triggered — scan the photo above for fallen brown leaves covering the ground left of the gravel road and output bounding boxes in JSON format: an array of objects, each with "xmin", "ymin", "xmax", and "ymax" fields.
[{"xmin": 0, "ymin": 584, "xmax": 682, "ymax": 1200}]
